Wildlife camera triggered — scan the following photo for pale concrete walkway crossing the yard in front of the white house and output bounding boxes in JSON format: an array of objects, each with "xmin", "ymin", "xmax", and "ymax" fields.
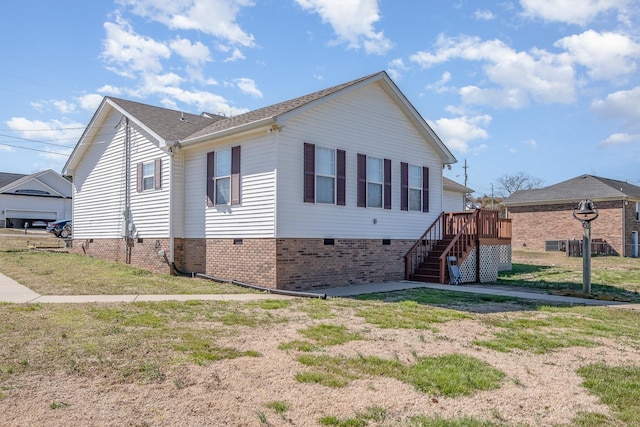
[{"xmin": 0, "ymin": 273, "xmax": 640, "ymax": 311}]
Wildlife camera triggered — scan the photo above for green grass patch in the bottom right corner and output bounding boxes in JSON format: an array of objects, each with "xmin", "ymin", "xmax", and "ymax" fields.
[{"xmin": 578, "ymin": 363, "xmax": 640, "ymax": 426}]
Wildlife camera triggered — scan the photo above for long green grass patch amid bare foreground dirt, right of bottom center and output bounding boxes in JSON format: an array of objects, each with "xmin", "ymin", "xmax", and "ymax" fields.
[{"xmin": 296, "ymin": 354, "xmax": 504, "ymax": 397}]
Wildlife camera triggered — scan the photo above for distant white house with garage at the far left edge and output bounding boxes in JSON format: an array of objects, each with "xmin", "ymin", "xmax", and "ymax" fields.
[{"xmin": 0, "ymin": 170, "xmax": 72, "ymax": 228}]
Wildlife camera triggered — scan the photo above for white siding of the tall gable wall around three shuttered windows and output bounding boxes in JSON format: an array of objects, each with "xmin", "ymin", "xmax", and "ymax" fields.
[{"xmin": 276, "ymin": 84, "xmax": 442, "ymax": 239}]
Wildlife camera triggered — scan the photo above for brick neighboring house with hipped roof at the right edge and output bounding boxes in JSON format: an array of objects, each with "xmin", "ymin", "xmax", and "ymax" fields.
[{"xmin": 503, "ymin": 175, "xmax": 640, "ymax": 257}]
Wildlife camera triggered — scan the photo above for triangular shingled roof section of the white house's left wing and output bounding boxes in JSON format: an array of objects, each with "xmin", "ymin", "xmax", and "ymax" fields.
[{"xmin": 108, "ymin": 96, "xmax": 225, "ymax": 142}]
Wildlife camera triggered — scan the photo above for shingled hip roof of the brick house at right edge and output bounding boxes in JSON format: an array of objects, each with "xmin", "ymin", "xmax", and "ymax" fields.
[{"xmin": 503, "ymin": 175, "xmax": 640, "ymax": 206}]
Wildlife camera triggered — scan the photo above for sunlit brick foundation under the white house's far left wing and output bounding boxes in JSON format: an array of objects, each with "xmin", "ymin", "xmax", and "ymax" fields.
[{"xmin": 70, "ymin": 239, "xmax": 171, "ymax": 274}]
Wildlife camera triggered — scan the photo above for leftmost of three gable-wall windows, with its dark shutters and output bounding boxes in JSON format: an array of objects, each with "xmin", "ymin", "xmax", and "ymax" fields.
[{"xmin": 304, "ymin": 142, "xmax": 346, "ymax": 206}]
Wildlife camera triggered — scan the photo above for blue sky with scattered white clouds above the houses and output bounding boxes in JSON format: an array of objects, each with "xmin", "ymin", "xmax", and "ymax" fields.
[{"xmin": 0, "ymin": 0, "xmax": 640, "ymax": 195}]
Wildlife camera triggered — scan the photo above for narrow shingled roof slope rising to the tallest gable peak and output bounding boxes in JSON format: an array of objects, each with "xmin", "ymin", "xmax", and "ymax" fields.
[{"xmin": 188, "ymin": 72, "xmax": 382, "ymax": 139}]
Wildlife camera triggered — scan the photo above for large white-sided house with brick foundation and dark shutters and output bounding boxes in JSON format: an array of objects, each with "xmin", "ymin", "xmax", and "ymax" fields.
[{"xmin": 63, "ymin": 72, "xmax": 464, "ymax": 289}]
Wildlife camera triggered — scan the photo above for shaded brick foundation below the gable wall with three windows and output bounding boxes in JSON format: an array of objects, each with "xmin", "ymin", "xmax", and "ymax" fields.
[{"xmin": 276, "ymin": 239, "xmax": 415, "ymax": 290}]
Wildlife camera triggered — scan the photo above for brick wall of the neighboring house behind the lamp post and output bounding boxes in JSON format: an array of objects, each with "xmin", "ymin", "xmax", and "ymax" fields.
[{"xmin": 508, "ymin": 200, "xmax": 623, "ymax": 254}]
